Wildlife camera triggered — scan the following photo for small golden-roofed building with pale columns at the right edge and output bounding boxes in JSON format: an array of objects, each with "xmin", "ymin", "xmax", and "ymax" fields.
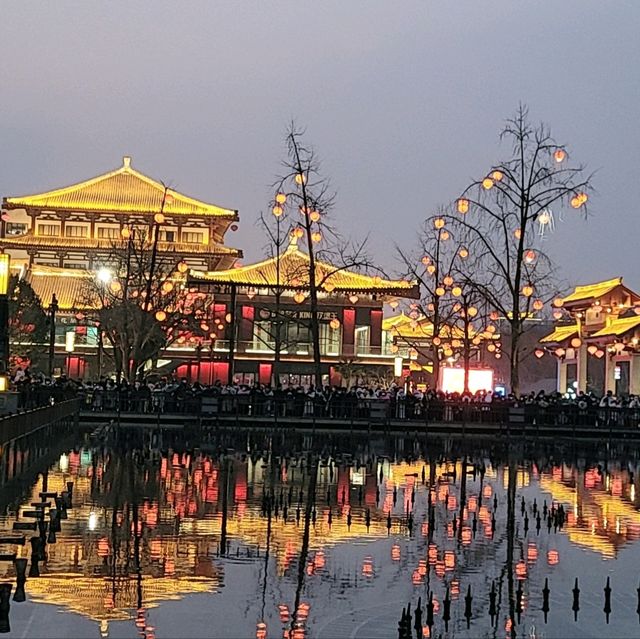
[{"xmin": 536, "ymin": 277, "xmax": 640, "ymax": 396}]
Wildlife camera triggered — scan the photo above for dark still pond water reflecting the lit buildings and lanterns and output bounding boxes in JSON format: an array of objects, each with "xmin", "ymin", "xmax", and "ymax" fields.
[{"xmin": 0, "ymin": 432, "xmax": 640, "ymax": 639}]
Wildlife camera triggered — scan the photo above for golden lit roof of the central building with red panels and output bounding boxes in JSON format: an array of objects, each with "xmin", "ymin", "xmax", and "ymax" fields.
[{"xmin": 190, "ymin": 240, "xmax": 418, "ymax": 297}]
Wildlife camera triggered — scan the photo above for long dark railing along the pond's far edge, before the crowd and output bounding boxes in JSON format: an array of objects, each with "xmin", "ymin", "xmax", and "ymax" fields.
[{"xmin": 77, "ymin": 391, "xmax": 640, "ymax": 429}]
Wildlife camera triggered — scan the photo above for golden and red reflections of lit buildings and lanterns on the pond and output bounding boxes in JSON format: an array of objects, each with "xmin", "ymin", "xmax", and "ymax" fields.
[{"xmin": 1, "ymin": 442, "xmax": 640, "ymax": 639}]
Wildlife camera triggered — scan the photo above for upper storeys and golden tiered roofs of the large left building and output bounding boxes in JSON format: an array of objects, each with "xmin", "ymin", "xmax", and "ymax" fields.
[{"xmin": 0, "ymin": 157, "xmax": 240, "ymax": 276}]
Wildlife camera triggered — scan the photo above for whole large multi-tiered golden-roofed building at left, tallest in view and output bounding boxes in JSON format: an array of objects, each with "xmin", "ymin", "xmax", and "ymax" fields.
[{"xmin": 0, "ymin": 157, "xmax": 242, "ymax": 377}]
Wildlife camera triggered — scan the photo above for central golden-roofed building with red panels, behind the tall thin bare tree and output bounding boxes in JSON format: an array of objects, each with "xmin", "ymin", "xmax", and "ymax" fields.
[{"xmin": 186, "ymin": 237, "xmax": 419, "ymax": 385}]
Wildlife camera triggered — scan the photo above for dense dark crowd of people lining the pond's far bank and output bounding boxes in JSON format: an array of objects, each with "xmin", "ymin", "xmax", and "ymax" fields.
[{"xmin": 12, "ymin": 370, "xmax": 640, "ymax": 421}]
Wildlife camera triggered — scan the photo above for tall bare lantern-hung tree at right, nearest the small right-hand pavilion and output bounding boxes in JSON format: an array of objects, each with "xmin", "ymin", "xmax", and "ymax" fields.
[{"xmin": 447, "ymin": 106, "xmax": 591, "ymax": 394}]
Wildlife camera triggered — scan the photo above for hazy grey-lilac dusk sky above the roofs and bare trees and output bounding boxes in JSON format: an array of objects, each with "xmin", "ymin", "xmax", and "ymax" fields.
[{"xmin": 0, "ymin": 0, "xmax": 640, "ymax": 288}]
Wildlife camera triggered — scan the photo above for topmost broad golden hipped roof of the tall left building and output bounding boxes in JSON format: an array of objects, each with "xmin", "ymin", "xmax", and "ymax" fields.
[{"xmin": 4, "ymin": 157, "xmax": 238, "ymax": 219}]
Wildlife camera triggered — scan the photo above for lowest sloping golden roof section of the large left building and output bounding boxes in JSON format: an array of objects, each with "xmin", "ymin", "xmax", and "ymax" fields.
[{"xmin": 26, "ymin": 265, "xmax": 95, "ymax": 311}]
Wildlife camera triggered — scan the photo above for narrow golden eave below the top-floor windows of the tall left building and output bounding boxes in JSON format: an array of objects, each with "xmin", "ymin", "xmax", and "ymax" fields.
[{"xmin": 0, "ymin": 235, "xmax": 242, "ymax": 256}]
